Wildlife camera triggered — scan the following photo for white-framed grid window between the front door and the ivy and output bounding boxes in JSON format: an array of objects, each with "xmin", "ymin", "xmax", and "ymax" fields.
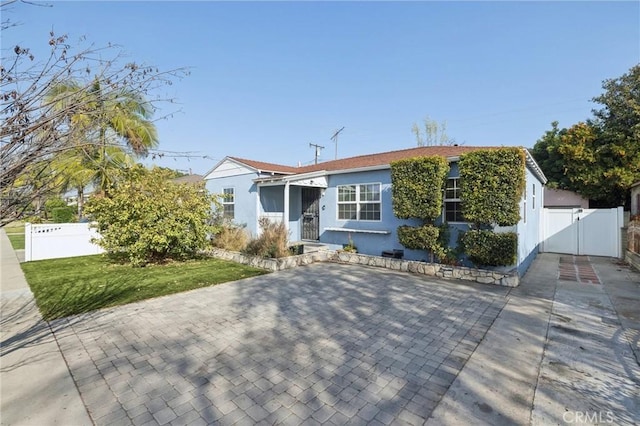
[{"xmin": 338, "ymin": 183, "xmax": 381, "ymax": 221}]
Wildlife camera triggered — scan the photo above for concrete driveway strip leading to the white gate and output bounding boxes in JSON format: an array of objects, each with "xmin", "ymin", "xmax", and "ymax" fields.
[{"xmin": 427, "ymin": 253, "xmax": 640, "ymax": 425}]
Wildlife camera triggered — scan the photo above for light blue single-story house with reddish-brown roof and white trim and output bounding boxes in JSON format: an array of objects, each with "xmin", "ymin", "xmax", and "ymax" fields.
[{"xmin": 204, "ymin": 146, "xmax": 546, "ymax": 273}]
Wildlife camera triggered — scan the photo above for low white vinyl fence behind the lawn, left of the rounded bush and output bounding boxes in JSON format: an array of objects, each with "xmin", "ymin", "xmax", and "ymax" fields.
[{"xmin": 24, "ymin": 223, "xmax": 104, "ymax": 262}]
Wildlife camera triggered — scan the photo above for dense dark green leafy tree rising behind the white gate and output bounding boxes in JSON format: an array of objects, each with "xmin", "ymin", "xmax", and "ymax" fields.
[{"xmin": 532, "ymin": 65, "xmax": 640, "ymax": 207}]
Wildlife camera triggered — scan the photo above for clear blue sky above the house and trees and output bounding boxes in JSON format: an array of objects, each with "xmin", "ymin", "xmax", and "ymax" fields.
[{"xmin": 2, "ymin": 1, "xmax": 640, "ymax": 173}]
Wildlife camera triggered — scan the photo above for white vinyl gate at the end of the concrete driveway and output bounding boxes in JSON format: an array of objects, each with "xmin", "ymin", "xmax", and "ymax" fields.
[{"xmin": 542, "ymin": 207, "xmax": 623, "ymax": 257}]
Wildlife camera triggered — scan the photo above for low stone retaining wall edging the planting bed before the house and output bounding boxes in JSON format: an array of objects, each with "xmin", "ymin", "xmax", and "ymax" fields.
[{"xmin": 207, "ymin": 248, "xmax": 520, "ymax": 287}]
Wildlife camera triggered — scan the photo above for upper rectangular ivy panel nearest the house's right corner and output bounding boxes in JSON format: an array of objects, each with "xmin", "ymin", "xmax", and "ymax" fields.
[{"xmin": 458, "ymin": 148, "xmax": 526, "ymax": 228}]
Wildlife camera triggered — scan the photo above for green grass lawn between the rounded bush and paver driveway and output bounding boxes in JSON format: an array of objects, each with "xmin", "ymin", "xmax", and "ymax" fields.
[{"xmin": 21, "ymin": 255, "xmax": 266, "ymax": 320}]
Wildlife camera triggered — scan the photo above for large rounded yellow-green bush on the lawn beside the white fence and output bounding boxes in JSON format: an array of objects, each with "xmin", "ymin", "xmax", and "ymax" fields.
[{"xmin": 85, "ymin": 165, "xmax": 216, "ymax": 266}]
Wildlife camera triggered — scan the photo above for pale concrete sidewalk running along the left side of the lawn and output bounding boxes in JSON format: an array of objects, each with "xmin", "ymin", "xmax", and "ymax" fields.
[{"xmin": 0, "ymin": 229, "xmax": 93, "ymax": 425}]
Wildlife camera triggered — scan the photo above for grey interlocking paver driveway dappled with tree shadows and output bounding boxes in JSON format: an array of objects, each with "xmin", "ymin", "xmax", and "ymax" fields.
[{"xmin": 52, "ymin": 264, "xmax": 508, "ymax": 425}]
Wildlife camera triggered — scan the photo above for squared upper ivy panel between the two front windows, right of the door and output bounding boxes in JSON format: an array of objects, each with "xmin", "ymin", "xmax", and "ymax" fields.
[{"xmin": 391, "ymin": 156, "xmax": 449, "ymax": 222}]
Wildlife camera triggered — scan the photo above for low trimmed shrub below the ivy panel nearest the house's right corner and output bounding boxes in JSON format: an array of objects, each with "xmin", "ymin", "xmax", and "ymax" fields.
[{"xmin": 460, "ymin": 230, "xmax": 518, "ymax": 266}]
